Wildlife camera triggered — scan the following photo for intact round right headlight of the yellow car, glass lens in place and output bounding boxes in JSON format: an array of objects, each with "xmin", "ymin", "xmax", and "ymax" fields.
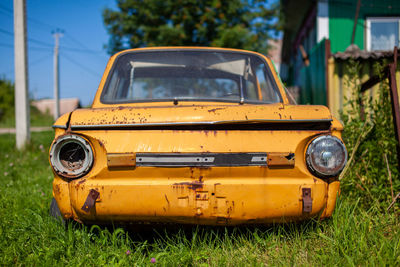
[{"xmin": 306, "ymin": 135, "xmax": 347, "ymax": 178}]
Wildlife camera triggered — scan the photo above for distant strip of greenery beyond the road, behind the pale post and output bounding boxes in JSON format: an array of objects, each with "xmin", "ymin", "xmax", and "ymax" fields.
[{"xmin": 0, "ymin": 106, "xmax": 54, "ymax": 128}]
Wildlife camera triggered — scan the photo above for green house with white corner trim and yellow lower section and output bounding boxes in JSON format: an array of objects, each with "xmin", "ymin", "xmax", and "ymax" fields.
[{"xmin": 281, "ymin": 0, "xmax": 400, "ymax": 116}]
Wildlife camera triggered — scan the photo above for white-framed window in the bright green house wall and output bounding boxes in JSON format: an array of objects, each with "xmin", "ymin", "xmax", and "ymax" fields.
[{"xmin": 366, "ymin": 17, "xmax": 400, "ymax": 51}]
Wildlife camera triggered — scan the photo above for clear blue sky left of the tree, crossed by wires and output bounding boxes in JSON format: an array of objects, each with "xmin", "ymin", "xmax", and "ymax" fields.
[{"xmin": 0, "ymin": 0, "xmax": 116, "ymax": 105}]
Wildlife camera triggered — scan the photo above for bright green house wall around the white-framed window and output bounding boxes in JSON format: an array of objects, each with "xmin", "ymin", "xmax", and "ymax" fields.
[{"xmin": 328, "ymin": 0, "xmax": 400, "ymax": 53}]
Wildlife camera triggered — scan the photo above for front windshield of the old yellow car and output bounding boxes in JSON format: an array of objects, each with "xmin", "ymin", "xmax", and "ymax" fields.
[{"xmin": 101, "ymin": 50, "xmax": 281, "ymax": 104}]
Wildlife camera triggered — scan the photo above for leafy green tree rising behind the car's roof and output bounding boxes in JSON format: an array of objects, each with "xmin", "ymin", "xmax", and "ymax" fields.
[{"xmin": 103, "ymin": 0, "xmax": 279, "ymax": 53}]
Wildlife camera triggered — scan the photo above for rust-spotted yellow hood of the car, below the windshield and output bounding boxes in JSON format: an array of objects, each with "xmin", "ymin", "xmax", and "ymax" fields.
[{"xmin": 64, "ymin": 104, "xmax": 332, "ymax": 127}]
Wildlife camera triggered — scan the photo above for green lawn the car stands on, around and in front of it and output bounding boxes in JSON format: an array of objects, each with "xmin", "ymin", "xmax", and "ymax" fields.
[{"xmin": 0, "ymin": 132, "xmax": 400, "ymax": 266}]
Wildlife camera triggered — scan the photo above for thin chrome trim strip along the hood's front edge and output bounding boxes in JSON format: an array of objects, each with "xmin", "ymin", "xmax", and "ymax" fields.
[{"xmin": 69, "ymin": 119, "xmax": 332, "ymax": 130}]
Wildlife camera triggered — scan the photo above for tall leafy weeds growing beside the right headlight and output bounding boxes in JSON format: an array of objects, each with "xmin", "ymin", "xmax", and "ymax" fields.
[{"xmin": 341, "ymin": 61, "xmax": 400, "ymax": 207}]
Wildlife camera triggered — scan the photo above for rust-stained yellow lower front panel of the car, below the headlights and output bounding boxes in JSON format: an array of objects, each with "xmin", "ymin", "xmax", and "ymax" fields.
[{"xmin": 53, "ymin": 172, "xmax": 340, "ymax": 225}]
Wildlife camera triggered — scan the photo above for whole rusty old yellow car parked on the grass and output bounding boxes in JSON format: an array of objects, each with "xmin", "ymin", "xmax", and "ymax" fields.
[{"xmin": 49, "ymin": 47, "xmax": 347, "ymax": 225}]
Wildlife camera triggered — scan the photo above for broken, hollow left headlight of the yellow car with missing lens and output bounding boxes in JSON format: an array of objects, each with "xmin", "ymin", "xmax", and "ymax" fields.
[{"xmin": 50, "ymin": 134, "xmax": 93, "ymax": 178}]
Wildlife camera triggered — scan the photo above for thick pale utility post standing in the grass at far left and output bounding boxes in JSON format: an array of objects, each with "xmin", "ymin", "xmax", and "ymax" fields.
[{"xmin": 14, "ymin": 0, "xmax": 30, "ymax": 149}]
